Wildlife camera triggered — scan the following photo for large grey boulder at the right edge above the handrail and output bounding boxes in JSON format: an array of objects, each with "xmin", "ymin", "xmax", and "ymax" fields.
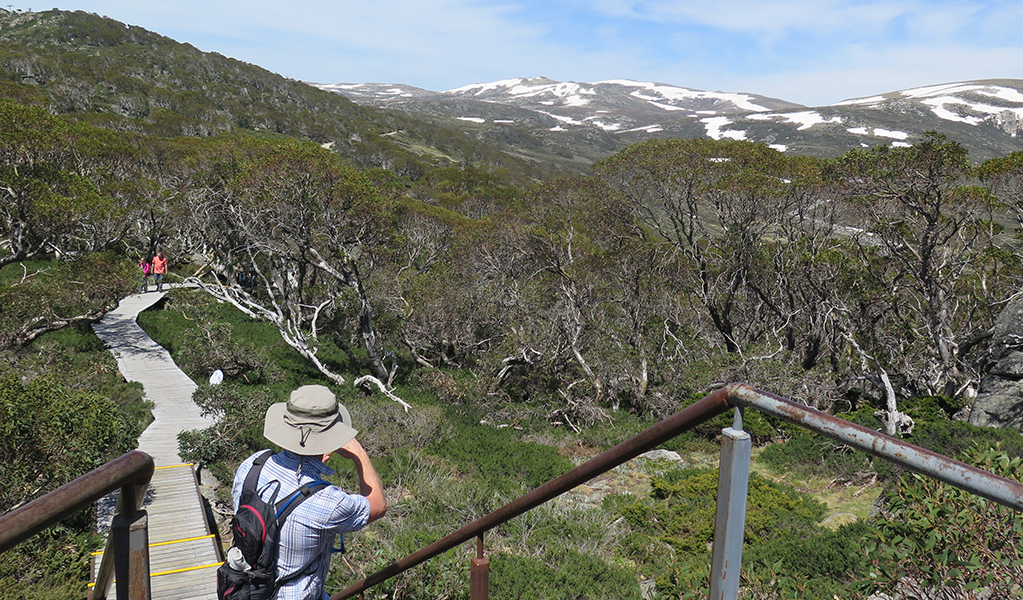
[{"xmin": 970, "ymin": 294, "xmax": 1023, "ymax": 430}]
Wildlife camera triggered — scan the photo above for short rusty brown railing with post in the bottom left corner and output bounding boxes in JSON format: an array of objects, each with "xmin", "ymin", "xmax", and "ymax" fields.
[{"xmin": 0, "ymin": 451, "xmax": 154, "ymax": 600}]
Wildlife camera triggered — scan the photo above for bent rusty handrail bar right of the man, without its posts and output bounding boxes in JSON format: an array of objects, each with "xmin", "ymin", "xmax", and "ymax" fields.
[{"xmin": 330, "ymin": 383, "xmax": 1023, "ymax": 600}]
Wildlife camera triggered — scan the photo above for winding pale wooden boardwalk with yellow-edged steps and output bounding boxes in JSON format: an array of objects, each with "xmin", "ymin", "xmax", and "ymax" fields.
[{"xmin": 92, "ymin": 286, "xmax": 221, "ymax": 600}]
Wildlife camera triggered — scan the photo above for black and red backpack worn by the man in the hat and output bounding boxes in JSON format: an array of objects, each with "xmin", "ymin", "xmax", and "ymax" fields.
[{"xmin": 217, "ymin": 450, "xmax": 329, "ymax": 600}]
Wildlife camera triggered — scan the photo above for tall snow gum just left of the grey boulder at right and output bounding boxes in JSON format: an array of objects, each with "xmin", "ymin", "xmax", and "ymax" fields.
[{"xmin": 829, "ymin": 133, "xmax": 995, "ymax": 430}]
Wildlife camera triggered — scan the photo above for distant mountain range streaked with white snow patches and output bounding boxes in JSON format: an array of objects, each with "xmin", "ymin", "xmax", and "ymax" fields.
[{"xmin": 314, "ymin": 78, "xmax": 1023, "ymax": 166}]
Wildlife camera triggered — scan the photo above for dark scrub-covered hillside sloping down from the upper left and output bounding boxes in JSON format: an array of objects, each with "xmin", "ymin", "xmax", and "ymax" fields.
[{"xmin": 0, "ymin": 9, "xmax": 553, "ymax": 178}]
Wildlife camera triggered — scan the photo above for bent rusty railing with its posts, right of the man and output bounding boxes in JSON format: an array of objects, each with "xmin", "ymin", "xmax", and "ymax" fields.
[{"xmin": 330, "ymin": 383, "xmax": 1023, "ymax": 600}]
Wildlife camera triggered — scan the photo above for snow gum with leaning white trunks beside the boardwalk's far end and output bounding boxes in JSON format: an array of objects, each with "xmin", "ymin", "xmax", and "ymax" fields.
[{"xmin": 182, "ymin": 143, "xmax": 405, "ymax": 406}]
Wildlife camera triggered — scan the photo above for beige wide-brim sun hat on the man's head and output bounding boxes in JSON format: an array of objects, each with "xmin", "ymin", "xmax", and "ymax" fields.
[{"xmin": 263, "ymin": 385, "xmax": 358, "ymax": 456}]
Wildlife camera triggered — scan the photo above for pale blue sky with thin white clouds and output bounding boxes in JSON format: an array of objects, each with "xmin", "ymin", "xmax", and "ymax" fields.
[{"xmin": 29, "ymin": 0, "xmax": 1023, "ymax": 106}]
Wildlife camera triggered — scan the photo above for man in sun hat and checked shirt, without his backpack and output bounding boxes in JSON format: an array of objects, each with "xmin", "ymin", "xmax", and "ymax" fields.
[{"xmin": 231, "ymin": 385, "xmax": 387, "ymax": 600}]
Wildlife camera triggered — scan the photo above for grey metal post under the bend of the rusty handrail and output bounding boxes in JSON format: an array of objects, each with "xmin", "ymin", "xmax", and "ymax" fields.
[{"xmin": 710, "ymin": 408, "xmax": 753, "ymax": 600}]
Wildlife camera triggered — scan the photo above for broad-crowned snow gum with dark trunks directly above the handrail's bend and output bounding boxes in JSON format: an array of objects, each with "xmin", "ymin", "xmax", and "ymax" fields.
[{"xmin": 595, "ymin": 139, "xmax": 831, "ymax": 366}]
